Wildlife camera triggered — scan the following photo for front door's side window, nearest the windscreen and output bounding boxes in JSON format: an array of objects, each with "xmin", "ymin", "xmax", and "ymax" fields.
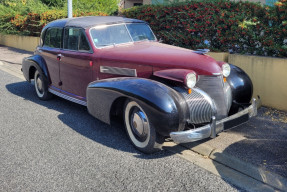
[{"xmin": 64, "ymin": 28, "xmax": 90, "ymax": 51}]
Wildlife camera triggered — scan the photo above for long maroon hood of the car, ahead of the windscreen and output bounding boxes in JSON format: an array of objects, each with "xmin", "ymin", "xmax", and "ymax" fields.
[{"xmin": 96, "ymin": 41, "xmax": 222, "ymax": 75}]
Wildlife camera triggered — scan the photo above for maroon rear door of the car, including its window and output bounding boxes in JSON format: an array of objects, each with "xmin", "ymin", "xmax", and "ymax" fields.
[{"xmin": 37, "ymin": 27, "xmax": 63, "ymax": 89}]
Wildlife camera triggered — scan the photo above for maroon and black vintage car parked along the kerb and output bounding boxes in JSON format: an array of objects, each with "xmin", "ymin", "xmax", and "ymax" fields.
[{"xmin": 22, "ymin": 16, "xmax": 258, "ymax": 153}]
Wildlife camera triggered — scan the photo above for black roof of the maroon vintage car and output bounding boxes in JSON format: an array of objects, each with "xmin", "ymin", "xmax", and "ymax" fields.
[{"xmin": 43, "ymin": 16, "xmax": 146, "ymax": 30}]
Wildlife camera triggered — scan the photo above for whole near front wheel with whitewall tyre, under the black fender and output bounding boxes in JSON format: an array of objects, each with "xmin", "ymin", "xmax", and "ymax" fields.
[{"xmin": 124, "ymin": 100, "xmax": 164, "ymax": 153}]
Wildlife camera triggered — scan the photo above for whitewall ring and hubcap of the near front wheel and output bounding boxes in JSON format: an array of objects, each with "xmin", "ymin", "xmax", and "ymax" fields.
[{"xmin": 125, "ymin": 101, "xmax": 153, "ymax": 148}]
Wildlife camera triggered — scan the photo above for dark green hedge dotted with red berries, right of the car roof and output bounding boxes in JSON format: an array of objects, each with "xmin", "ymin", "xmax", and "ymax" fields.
[{"xmin": 122, "ymin": 0, "xmax": 287, "ymax": 57}]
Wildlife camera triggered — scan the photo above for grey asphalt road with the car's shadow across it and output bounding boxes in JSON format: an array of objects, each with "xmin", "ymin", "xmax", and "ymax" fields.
[{"xmin": 0, "ymin": 70, "xmax": 241, "ymax": 191}]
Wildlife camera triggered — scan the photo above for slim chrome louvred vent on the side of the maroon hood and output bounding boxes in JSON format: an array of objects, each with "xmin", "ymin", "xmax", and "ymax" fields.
[{"xmin": 100, "ymin": 66, "xmax": 137, "ymax": 77}]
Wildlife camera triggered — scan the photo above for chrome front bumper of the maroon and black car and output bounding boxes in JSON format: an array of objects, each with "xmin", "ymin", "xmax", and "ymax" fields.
[{"xmin": 170, "ymin": 98, "xmax": 259, "ymax": 143}]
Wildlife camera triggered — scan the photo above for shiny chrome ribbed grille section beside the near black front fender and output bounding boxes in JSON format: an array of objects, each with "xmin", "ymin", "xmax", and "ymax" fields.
[{"xmin": 174, "ymin": 87, "xmax": 215, "ymax": 124}]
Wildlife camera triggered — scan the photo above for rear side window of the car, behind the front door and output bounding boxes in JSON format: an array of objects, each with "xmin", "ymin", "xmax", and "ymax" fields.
[{"xmin": 43, "ymin": 28, "xmax": 62, "ymax": 48}]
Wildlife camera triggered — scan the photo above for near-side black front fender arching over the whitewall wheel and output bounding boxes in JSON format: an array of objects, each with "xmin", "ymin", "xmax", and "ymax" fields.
[{"xmin": 87, "ymin": 78, "xmax": 188, "ymax": 136}]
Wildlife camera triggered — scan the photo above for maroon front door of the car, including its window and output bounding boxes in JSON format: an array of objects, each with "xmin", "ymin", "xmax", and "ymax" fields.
[{"xmin": 60, "ymin": 27, "xmax": 93, "ymax": 101}]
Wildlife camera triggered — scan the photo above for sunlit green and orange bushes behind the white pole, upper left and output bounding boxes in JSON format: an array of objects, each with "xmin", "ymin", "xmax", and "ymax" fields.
[{"xmin": 0, "ymin": 0, "xmax": 117, "ymax": 36}]
